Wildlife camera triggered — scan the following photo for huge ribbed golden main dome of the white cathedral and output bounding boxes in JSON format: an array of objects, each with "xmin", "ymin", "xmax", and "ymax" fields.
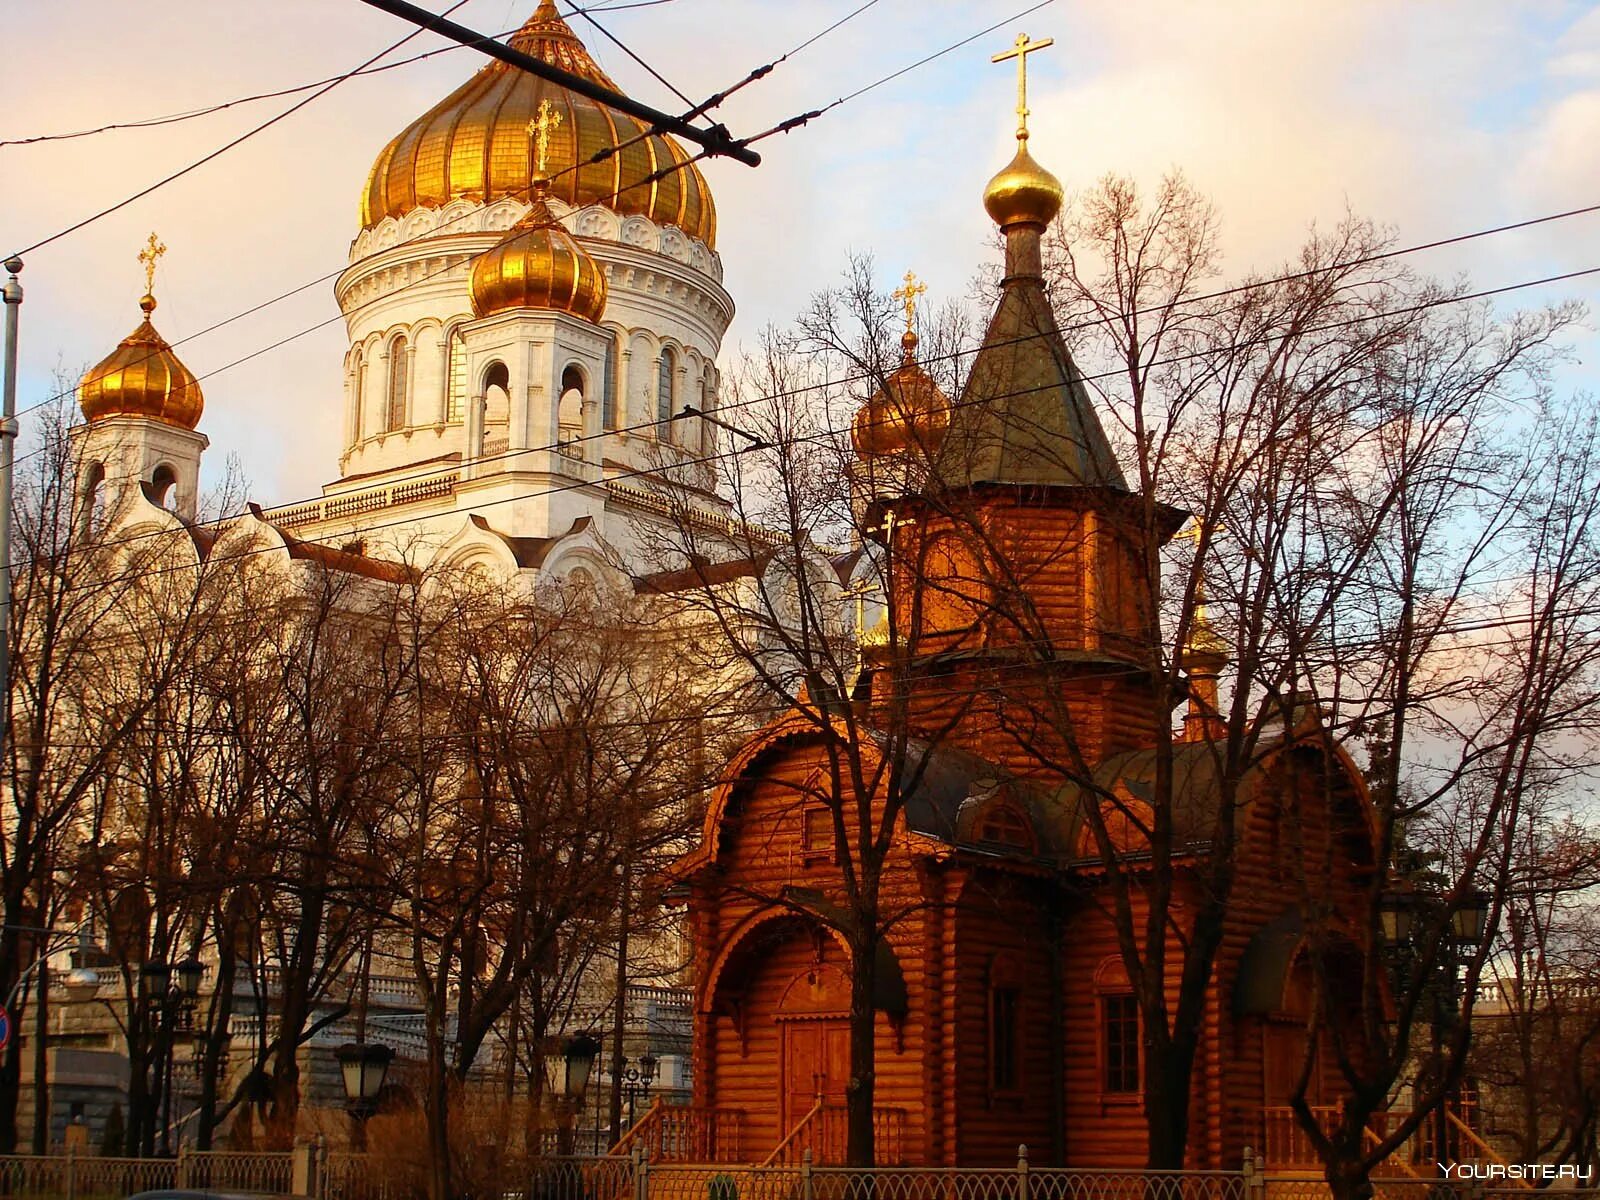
[{"xmin": 362, "ymin": 0, "xmax": 717, "ymax": 248}]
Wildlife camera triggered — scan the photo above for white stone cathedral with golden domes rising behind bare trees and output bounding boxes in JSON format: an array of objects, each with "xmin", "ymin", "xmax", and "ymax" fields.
[{"xmin": 75, "ymin": 0, "xmax": 734, "ymax": 582}]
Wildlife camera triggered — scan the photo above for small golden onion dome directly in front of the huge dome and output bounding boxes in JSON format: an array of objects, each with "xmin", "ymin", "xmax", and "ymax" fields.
[{"xmin": 472, "ymin": 186, "xmax": 606, "ymax": 323}]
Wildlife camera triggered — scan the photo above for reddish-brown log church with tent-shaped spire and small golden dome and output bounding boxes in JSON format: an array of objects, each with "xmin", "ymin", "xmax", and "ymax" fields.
[{"xmin": 656, "ymin": 40, "xmax": 1371, "ymax": 1168}]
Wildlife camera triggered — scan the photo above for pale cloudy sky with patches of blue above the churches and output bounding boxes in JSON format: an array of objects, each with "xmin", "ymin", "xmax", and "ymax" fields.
[{"xmin": 0, "ymin": 0, "xmax": 1600, "ymax": 504}]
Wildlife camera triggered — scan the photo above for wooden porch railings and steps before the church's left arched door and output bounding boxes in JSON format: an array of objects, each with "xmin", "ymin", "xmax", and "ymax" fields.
[{"xmin": 611, "ymin": 1099, "xmax": 906, "ymax": 1166}]
